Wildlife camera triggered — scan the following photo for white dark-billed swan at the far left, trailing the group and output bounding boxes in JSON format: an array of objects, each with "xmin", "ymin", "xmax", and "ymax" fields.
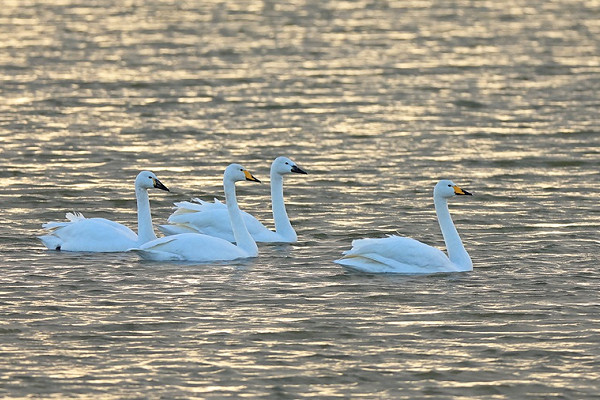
[{"xmin": 39, "ymin": 171, "xmax": 169, "ymax": 252}]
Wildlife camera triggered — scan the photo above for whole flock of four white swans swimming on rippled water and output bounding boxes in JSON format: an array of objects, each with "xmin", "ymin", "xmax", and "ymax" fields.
[{"xmin": 39, "ymin": 157, "xmax": 473, "ymax": 274}]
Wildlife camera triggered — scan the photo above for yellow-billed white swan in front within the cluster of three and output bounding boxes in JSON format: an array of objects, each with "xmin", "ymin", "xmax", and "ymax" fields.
[{"xmin": 131, "ymin": 164, "xmax": 260, "ymax": 262}]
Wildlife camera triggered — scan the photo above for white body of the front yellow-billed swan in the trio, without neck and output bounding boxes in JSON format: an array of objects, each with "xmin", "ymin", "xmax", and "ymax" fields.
[{"xmin": 131, "ymin": 233, "xmax": 249, "ymax": 262}]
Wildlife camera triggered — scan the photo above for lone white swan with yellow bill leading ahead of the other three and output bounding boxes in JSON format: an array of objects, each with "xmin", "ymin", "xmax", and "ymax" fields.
[{"xmin": 335, "ymin": 180, "xmax": 473, "ymax": 274}]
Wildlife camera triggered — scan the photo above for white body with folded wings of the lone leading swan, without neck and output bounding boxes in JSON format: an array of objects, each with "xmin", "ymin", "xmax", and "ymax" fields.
[{"xmin": 336, "ymin": 236, "xmax": 457, "ymax": 274}]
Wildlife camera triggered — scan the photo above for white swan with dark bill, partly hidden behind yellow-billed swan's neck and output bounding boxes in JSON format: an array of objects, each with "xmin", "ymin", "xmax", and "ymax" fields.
[{"xmin": 158, "ymin": 157, "xmax": 306, "ymax": 243}]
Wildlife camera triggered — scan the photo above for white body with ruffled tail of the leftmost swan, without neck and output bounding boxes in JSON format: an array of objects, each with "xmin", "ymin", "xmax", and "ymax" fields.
[{"xmin": 39, "ymin": 213, "xmax": 137, "ymax": 252}]
